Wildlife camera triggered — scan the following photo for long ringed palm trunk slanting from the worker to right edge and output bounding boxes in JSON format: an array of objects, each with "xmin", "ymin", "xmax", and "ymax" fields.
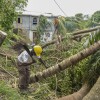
[{"xmin": 30, "ymin": 41, "xmax": 100, "ymax": 83}]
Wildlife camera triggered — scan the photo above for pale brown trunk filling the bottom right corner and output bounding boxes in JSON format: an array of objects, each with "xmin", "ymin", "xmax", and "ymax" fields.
[{"xmin": 83, "ymin": 77, "xmax": 100, "ymax": 100}]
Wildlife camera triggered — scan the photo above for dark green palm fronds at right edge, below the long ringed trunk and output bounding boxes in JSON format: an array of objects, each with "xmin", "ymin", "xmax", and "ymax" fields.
[{"xmin": 83, "ymin": 50, "xmax": 100, "ymax": 86}]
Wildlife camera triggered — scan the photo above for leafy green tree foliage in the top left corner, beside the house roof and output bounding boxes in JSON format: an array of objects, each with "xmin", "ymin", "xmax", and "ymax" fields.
[{"xmin": 0, "ymin": 0, "xmax": 27, "ymax": 30}]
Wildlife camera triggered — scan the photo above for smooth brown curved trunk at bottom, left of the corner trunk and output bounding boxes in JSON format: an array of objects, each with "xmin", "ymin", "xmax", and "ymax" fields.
[{"xmin": 57, "ymin": 83, "xmax": 90, "ymax": 100}]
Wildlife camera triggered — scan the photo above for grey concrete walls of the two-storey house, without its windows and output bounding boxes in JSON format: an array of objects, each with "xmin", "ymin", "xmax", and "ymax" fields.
[{"xmin": 14, "ymin": 15, "xmax": 54, "ymax": 42}]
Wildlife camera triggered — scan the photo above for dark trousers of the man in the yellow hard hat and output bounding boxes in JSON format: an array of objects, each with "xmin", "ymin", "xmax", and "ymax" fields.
[{"xmin": 17, "ymin": 62, "xmax": 30, "ymax": 89}]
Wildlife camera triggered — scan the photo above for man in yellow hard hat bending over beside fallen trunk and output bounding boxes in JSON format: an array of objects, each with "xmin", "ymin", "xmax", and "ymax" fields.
[{"xmin": 17, "ymin": 45, "xmax": 47, "ymax": 90}]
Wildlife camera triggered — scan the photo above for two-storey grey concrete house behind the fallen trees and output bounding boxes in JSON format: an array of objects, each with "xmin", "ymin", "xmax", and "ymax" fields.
[{"xmin": 14, "ymin": 14, "xmax": 57, "ymax": 42}]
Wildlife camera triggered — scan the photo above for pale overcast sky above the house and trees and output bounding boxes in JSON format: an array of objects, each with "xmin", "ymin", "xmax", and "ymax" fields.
[{"xmin": 25, "ymin": 0, "xmax": 100, "ymax": 16}]
